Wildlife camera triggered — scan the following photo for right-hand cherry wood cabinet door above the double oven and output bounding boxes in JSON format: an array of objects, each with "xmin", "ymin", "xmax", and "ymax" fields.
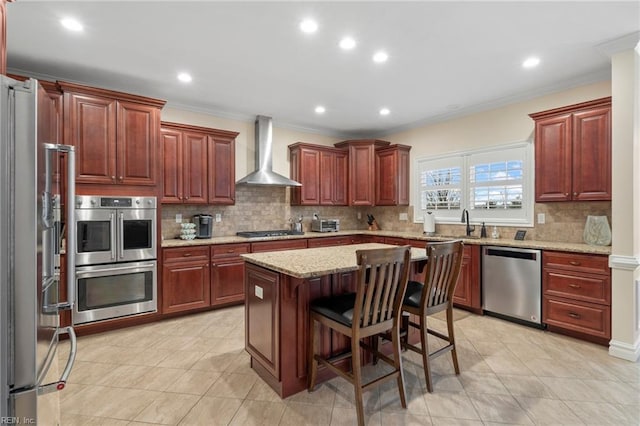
[{"xmin": 116, "ymin": 101, "xmax": 160, "ymax": 185}]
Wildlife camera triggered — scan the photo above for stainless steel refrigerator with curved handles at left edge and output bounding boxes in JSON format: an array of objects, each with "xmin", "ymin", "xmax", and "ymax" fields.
[{"xmin": 0, "ymin": 76, "xmax": 76, "ymax": 425}]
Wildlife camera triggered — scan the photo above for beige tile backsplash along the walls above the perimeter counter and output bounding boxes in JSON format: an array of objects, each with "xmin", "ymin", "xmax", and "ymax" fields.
[{"xmin": 162, "ymin": 185, "xmax": 613, "ymax": 243}]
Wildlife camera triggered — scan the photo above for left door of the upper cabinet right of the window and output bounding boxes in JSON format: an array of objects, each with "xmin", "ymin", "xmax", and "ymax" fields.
[{"xmin": 535, "ymin": 114, "xmax": 572, "ymax": 202}]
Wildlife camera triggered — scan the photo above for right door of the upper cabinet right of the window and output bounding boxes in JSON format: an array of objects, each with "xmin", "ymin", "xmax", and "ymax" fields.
[{"xmin": 573, "ymin": 107, "xmax": 611, "ymax": 201}]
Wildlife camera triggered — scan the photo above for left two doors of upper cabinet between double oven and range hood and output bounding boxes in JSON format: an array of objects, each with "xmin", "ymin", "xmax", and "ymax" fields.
[{"xmin": 161, "ymin": 125, "xmax": 208, "ymax": 204}]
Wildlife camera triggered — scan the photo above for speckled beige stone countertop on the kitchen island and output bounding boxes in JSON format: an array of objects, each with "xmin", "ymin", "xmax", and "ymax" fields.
[{"xmin": 241, "ymin": 243, "xmax": 427, "ymax": 279}]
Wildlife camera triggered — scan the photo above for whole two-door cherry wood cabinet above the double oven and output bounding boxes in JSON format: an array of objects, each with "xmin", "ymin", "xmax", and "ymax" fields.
[{"xmin": 58, "ymin": 82, "xmax": 164, "ymax": 190}]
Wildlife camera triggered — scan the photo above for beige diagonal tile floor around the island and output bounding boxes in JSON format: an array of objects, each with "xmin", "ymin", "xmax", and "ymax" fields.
[{"xmin": 60, "ymin": 306, "xmax": 640, "ymax": 426}]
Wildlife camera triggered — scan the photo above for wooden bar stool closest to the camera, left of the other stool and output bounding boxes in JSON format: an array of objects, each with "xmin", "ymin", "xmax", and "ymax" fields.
[{"xmin": 308, "ymin": 246, "xmax": 411, "ymax": 425}]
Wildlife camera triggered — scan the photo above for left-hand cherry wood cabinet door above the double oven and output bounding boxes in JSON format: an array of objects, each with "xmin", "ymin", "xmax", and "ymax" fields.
[{"xmin": 64, "ymin": 93, "xmax": 117, "ymax": 184}]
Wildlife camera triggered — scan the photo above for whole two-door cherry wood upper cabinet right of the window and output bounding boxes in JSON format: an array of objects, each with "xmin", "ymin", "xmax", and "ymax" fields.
[{"xmin": 530, "ymin": 98, "xmax": 611, "ymax": 202}]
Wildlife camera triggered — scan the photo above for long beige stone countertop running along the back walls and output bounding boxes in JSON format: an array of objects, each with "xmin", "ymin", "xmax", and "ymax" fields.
[{"xmin": 162, "ymin": 230, "xmax": 611, "ymax": 255}]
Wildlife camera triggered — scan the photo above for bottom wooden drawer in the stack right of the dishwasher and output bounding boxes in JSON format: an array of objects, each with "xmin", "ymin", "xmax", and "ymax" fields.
[{"xmin": 543, "ymin": 296, "xmax": 611, "ymax": 339}]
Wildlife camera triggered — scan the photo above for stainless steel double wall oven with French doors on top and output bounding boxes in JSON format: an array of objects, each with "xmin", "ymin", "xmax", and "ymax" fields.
[{"xmin": 72, "ymin": 195, "xmax": 157, "ymax": 324}]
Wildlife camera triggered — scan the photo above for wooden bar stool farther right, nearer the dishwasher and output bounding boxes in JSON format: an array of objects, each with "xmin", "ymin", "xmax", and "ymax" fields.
[{"xmin": 402, "ymin": 240, "xmax": 464, "ymax": 392}]
